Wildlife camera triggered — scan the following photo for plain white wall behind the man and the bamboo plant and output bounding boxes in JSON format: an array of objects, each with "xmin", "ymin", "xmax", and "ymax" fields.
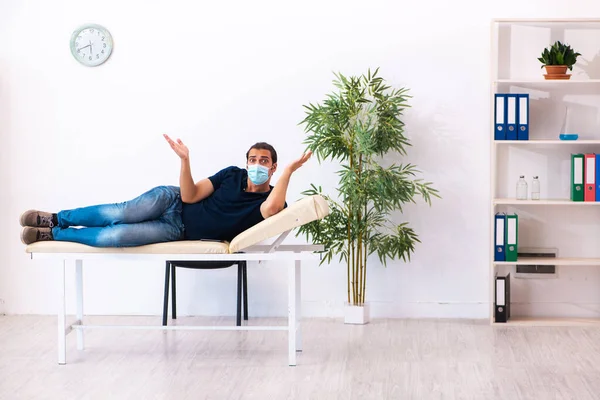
[{"xmin": 0, "ymin": 0, "xmax": 600, "ymax": 318}]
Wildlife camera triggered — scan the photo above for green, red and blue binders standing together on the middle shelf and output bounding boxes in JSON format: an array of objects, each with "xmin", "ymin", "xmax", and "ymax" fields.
[{"xmin": 571, "ymin": 153, "xmax": 600, "ymax": 201}]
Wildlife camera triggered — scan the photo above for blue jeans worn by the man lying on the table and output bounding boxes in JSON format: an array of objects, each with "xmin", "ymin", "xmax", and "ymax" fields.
[{"xmin": 52, "ymin": 186, "xmax": 184, "ymax": 247}]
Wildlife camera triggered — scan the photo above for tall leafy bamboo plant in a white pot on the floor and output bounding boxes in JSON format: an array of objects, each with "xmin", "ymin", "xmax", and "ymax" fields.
[{"xmin": 297, "ymin": 69, "xmax": 440, "ymax": 323}]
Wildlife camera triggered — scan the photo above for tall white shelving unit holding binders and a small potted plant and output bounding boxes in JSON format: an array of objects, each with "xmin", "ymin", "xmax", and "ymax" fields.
[{"xmin": 489, "ymin": 19, "xmax": 600, "ymax": 326}]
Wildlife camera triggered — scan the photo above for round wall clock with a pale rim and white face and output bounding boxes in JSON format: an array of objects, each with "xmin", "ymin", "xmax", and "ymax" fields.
[{"xmin": 71, "ymin": 24, "xmax": 113, "ymax": 67}]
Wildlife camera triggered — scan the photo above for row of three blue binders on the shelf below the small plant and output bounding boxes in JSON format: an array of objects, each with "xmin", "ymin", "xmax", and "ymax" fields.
[{"xmin": 494, "ymin": 93, "xmax": 529, "ymax": 140}]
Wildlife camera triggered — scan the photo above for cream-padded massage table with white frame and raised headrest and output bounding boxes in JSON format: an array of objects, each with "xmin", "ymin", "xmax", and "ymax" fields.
[{"xmin": 25, "ymin": 195, "xmax": 329, "ymax": 366}]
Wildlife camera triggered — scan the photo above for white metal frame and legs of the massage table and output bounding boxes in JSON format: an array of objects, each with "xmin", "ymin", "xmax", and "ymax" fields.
[{"xmin": 31, "ymin": 231, "xmax": 323, "ymax": 366}]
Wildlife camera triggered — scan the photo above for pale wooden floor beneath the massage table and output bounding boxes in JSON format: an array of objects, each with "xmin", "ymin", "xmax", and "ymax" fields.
[{"xmin": 0, "ymin": 316, "xmax": 600, "ymax": 400}]
